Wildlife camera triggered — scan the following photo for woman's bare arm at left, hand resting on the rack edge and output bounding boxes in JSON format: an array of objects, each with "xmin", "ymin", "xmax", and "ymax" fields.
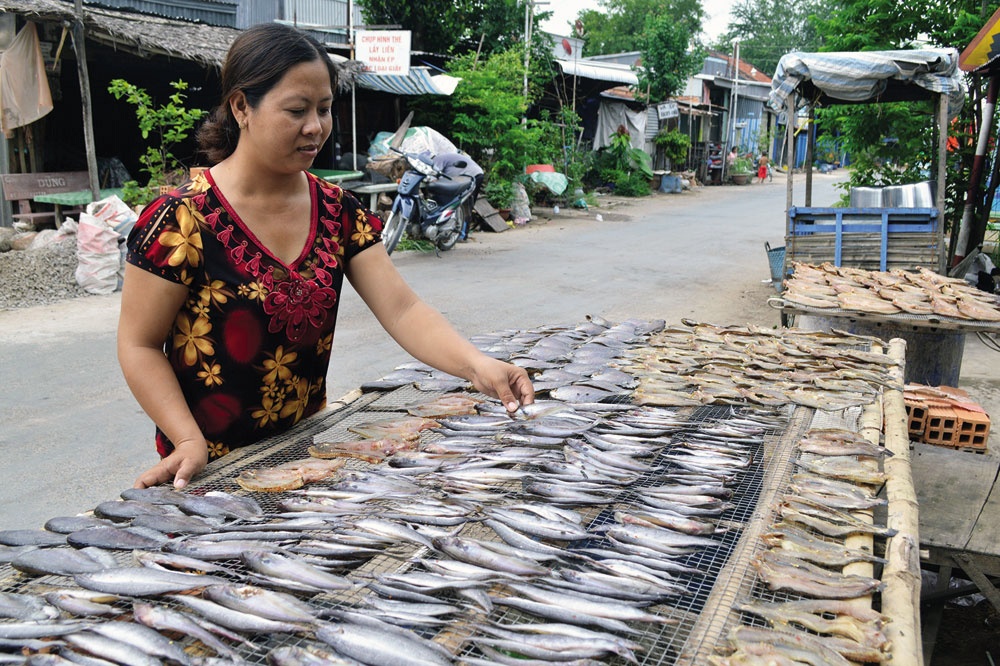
[{"xmin": 118, "ymin": 264, "xmax": 208, "ymax": 488}]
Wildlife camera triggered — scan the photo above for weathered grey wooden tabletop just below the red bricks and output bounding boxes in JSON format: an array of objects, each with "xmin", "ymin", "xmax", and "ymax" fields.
[{"xmin": 911, "ymin": 442, "xmax": 1000, "ymax": 552}]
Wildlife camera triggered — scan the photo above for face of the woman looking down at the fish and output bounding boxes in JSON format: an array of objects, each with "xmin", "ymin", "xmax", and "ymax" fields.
[{"xmin": 236, "ymin": 60, "xmax": 333, "ymax": 172}]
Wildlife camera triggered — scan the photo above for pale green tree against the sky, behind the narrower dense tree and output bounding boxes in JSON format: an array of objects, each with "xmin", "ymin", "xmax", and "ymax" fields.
[{"xmin": 577, "ymin": 0, "xmax": 705, "ymax": 56}]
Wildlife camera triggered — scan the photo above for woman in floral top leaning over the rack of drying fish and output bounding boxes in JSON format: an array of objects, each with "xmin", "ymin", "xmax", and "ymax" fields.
[{"xmin": 118, "ymin": 24, "xmax": 534, "ymax": 488}]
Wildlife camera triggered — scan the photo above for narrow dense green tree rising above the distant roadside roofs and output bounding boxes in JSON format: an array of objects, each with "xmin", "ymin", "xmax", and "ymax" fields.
[{"xmin": 638, "ymin": 14, "xmax": 705, "ymax": 101}]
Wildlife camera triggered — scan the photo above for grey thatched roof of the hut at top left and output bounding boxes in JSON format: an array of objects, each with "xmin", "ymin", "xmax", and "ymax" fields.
[{"xmin": 0, "ymin": 0, "xmax": 240, "ymax": 68}]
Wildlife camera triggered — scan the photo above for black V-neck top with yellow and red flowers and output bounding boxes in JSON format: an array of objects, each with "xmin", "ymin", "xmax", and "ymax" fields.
[{"xmin": 127, "ymin": 172, "xmax": 382, "ymax": 459}]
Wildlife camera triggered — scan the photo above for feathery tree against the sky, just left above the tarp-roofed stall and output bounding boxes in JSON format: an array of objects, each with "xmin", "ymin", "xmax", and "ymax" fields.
[{"xmin": 715, "ymin": 0, "xmax": 833, "ymax": 74}]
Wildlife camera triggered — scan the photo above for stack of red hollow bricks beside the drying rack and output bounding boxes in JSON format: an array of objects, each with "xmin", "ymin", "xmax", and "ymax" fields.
[{"xmin": 903, "ymin": 384, "xmax": 990, "ymax": 453}]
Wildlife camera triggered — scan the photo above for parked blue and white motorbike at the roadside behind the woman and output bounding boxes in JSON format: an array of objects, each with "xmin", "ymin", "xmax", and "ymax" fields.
[{"xmin": 382, "ymin": 150, "xmax": 476, "ymax": 254}]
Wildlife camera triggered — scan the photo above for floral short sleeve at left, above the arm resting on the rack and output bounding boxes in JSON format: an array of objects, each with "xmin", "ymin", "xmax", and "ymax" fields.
[{"xmin": 126, "ymin": 195, "xmax": 204, "ymax": 284}]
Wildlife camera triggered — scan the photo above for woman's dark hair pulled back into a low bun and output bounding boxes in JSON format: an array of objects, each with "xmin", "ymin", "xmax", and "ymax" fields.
[{"xmin": 197, "ymin": 23, "xmax": 337, "ymax": 164}]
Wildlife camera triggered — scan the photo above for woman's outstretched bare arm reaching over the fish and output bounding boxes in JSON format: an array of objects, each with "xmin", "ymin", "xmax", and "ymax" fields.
[{"xmin": 346, "ymin": 243, "xmax": 535, "ymax": 411}]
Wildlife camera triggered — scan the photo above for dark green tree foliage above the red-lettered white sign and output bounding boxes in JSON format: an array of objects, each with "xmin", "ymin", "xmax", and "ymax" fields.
[{"xmin": 359, "ymin": 0, "xmax": 546, "ymax": 54}]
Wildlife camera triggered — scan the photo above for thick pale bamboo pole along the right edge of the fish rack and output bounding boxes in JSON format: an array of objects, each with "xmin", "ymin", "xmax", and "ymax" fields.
[{"xmin": 882, "ymin": 338, "xmax": 924, "ymax": 666}]
